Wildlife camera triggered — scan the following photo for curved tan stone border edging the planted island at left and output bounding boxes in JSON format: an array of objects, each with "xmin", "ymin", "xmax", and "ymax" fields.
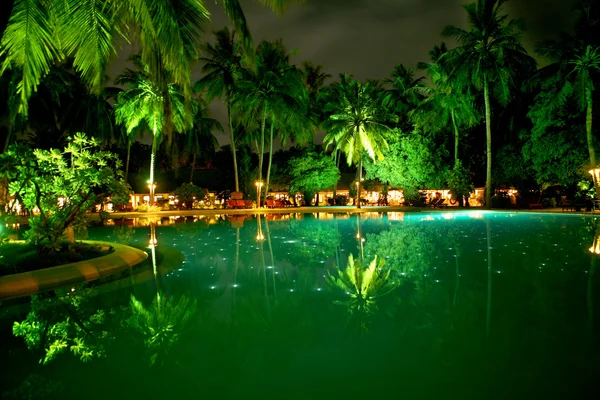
[{"xmin": 0, "ymin": 240, "xmax": 148, "ymax": 301}]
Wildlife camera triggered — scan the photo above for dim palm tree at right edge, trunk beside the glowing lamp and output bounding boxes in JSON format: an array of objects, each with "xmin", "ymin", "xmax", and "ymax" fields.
[{"xmin": 536, "ymin": 35, "xmax": 600, "ymax": 199}]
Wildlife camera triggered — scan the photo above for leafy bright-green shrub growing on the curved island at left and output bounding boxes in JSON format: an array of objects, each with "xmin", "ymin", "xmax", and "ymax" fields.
[{"xmin": 0, "ymin": 133, "xmax": 129, "ymax": 253}]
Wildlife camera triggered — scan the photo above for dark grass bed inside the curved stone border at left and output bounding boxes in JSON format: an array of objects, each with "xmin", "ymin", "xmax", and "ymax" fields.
[{"xmin": 0, "ymin": 242, "xmax": 113, "ymax": 276}]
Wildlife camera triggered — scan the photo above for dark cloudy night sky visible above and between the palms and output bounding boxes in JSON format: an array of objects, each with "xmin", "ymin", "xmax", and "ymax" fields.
[{"xmin": 192, "ymin": 0, "xmax": 575, "ymax": 143}]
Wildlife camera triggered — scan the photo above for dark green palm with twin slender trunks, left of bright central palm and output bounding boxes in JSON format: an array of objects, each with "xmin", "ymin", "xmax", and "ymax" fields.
[{"xmin": 234, "ymin": 41, "xmax": 306, "ymax": 206}]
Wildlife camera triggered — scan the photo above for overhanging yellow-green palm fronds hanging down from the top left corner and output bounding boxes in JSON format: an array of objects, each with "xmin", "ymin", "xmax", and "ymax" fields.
[{"xmin": 0, "ymin": 0, "xmax": 300, "ymax": 133}]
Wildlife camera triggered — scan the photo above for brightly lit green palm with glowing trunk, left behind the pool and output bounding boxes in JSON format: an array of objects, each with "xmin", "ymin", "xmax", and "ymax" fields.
[{"xmin": 115, "ymin": 57, "xmax": 186, "ymax": 204}]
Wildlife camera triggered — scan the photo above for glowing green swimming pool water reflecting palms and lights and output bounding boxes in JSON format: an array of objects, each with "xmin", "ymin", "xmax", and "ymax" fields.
[{"xmin": 0, "ymin": 212, "xmax": 600, "ymax": 399}]
